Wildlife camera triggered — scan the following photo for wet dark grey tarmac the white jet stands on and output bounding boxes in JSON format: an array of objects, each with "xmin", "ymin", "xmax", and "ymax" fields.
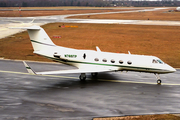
[{"xmin": 0, "ymin": 60, "xmax": 180, "ymax": 120}]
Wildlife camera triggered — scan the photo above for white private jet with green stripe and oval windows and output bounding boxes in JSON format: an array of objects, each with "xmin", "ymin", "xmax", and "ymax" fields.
[{"xmin": 21, "ymin": 26, "xmax": 176, "ymax": 84}]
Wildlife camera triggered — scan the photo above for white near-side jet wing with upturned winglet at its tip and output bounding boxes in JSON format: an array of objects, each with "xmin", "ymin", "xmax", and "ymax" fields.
[{"xmin": 23, "ymin": 61, "xmax": 117, "ymax": 75}]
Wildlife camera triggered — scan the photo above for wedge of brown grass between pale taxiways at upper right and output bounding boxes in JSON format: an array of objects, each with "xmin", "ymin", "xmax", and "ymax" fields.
[{"xmin": 69, "ymin": 8, "xmax": 180, "ymax": 21}]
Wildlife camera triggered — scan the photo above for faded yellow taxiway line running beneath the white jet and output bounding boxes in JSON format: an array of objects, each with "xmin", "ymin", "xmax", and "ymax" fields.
[{"xmin": 0, "ymin": 70, "xmax": 180, "ymax": 86}]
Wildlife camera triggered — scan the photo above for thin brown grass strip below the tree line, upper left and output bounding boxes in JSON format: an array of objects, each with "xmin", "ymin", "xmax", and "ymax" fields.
[{"xmin": 0, "ymin": 7, "xmax": 142, "ymax": 17}]
